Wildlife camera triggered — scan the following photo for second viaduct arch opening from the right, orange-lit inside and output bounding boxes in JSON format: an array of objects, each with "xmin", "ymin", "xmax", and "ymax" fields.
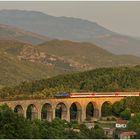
[{"xmin": 86, "ymin": 101, "xmax": 99, "ymax": 120}]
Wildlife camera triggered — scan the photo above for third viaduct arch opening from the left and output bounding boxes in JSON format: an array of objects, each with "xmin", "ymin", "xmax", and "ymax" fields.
[{"xmin": 41, "ymin": 103, "xmax": 53, "ymax": 121}]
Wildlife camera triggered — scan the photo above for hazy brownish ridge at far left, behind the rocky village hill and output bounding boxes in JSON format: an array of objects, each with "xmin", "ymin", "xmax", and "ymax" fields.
[{"xmin": 0, "ymin": 24, "xmax": 50, "ymax": 44}]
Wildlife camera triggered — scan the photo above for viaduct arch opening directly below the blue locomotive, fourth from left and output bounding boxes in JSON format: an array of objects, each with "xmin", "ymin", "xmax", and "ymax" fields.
[{"xmin": 55, "ymin": 103, "xmax": 67, "ymax": 120}]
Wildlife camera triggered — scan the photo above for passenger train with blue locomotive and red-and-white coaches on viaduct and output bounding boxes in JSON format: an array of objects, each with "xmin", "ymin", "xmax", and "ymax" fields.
[{"xmin": 54, "ymin": 92, "xmax": 140, "ymax": 98}]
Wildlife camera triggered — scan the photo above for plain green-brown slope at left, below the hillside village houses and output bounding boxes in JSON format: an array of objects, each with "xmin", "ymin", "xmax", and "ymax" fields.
[{"xmin": 0, "ymin": 50, "xmax": 75, "ymax": 86}]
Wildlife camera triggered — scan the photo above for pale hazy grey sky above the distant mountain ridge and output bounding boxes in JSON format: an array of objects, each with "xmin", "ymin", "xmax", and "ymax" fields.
[{"xmin": 0, "ymin": 1, "xmax": 140, "ymax": 37}]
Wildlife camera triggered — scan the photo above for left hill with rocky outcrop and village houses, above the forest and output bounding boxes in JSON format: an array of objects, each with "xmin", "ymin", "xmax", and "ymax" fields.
[{"xmin": 0, "ymin": 40, "xmax": 74, "ymax": 86}]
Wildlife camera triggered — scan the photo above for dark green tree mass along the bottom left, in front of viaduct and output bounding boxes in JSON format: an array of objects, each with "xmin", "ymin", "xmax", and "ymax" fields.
[{"xmin": 0, "ymin": 105, "xmax": 106, "ymax": 139}]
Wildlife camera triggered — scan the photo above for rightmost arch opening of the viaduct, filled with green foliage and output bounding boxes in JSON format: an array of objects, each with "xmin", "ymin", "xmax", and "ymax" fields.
[{"xmin": 101, "ymin": 101, "xmax": 112, "ymax": 117}]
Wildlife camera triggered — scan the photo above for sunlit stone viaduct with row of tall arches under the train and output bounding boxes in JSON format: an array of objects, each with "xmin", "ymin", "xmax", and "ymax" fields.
[{"xmin": 0, "ymin": 97, "xmax": 123, "ymax": 123}]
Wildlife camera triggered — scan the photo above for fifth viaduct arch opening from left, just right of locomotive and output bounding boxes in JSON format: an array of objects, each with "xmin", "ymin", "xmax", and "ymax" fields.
[{"xmin": 70, "ymin": 102, "xmax": 82, "ymax": 122}]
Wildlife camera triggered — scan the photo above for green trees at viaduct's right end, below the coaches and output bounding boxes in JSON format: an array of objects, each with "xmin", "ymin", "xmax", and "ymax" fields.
[{"xmin": 101, "ymin": 97, "xmax": 133, "ymax": 120}]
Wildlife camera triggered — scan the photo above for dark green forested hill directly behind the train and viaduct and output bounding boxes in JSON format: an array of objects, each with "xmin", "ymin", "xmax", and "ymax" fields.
[{"xmin": 0, "ymin": 66, "xmax": 140, "ymax": 99}]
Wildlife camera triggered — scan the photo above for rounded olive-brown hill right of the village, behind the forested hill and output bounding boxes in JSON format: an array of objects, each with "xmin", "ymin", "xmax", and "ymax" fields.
[{"xmin": 37, "ymin": 40, "xmax": 140, "ymax": 70}]
